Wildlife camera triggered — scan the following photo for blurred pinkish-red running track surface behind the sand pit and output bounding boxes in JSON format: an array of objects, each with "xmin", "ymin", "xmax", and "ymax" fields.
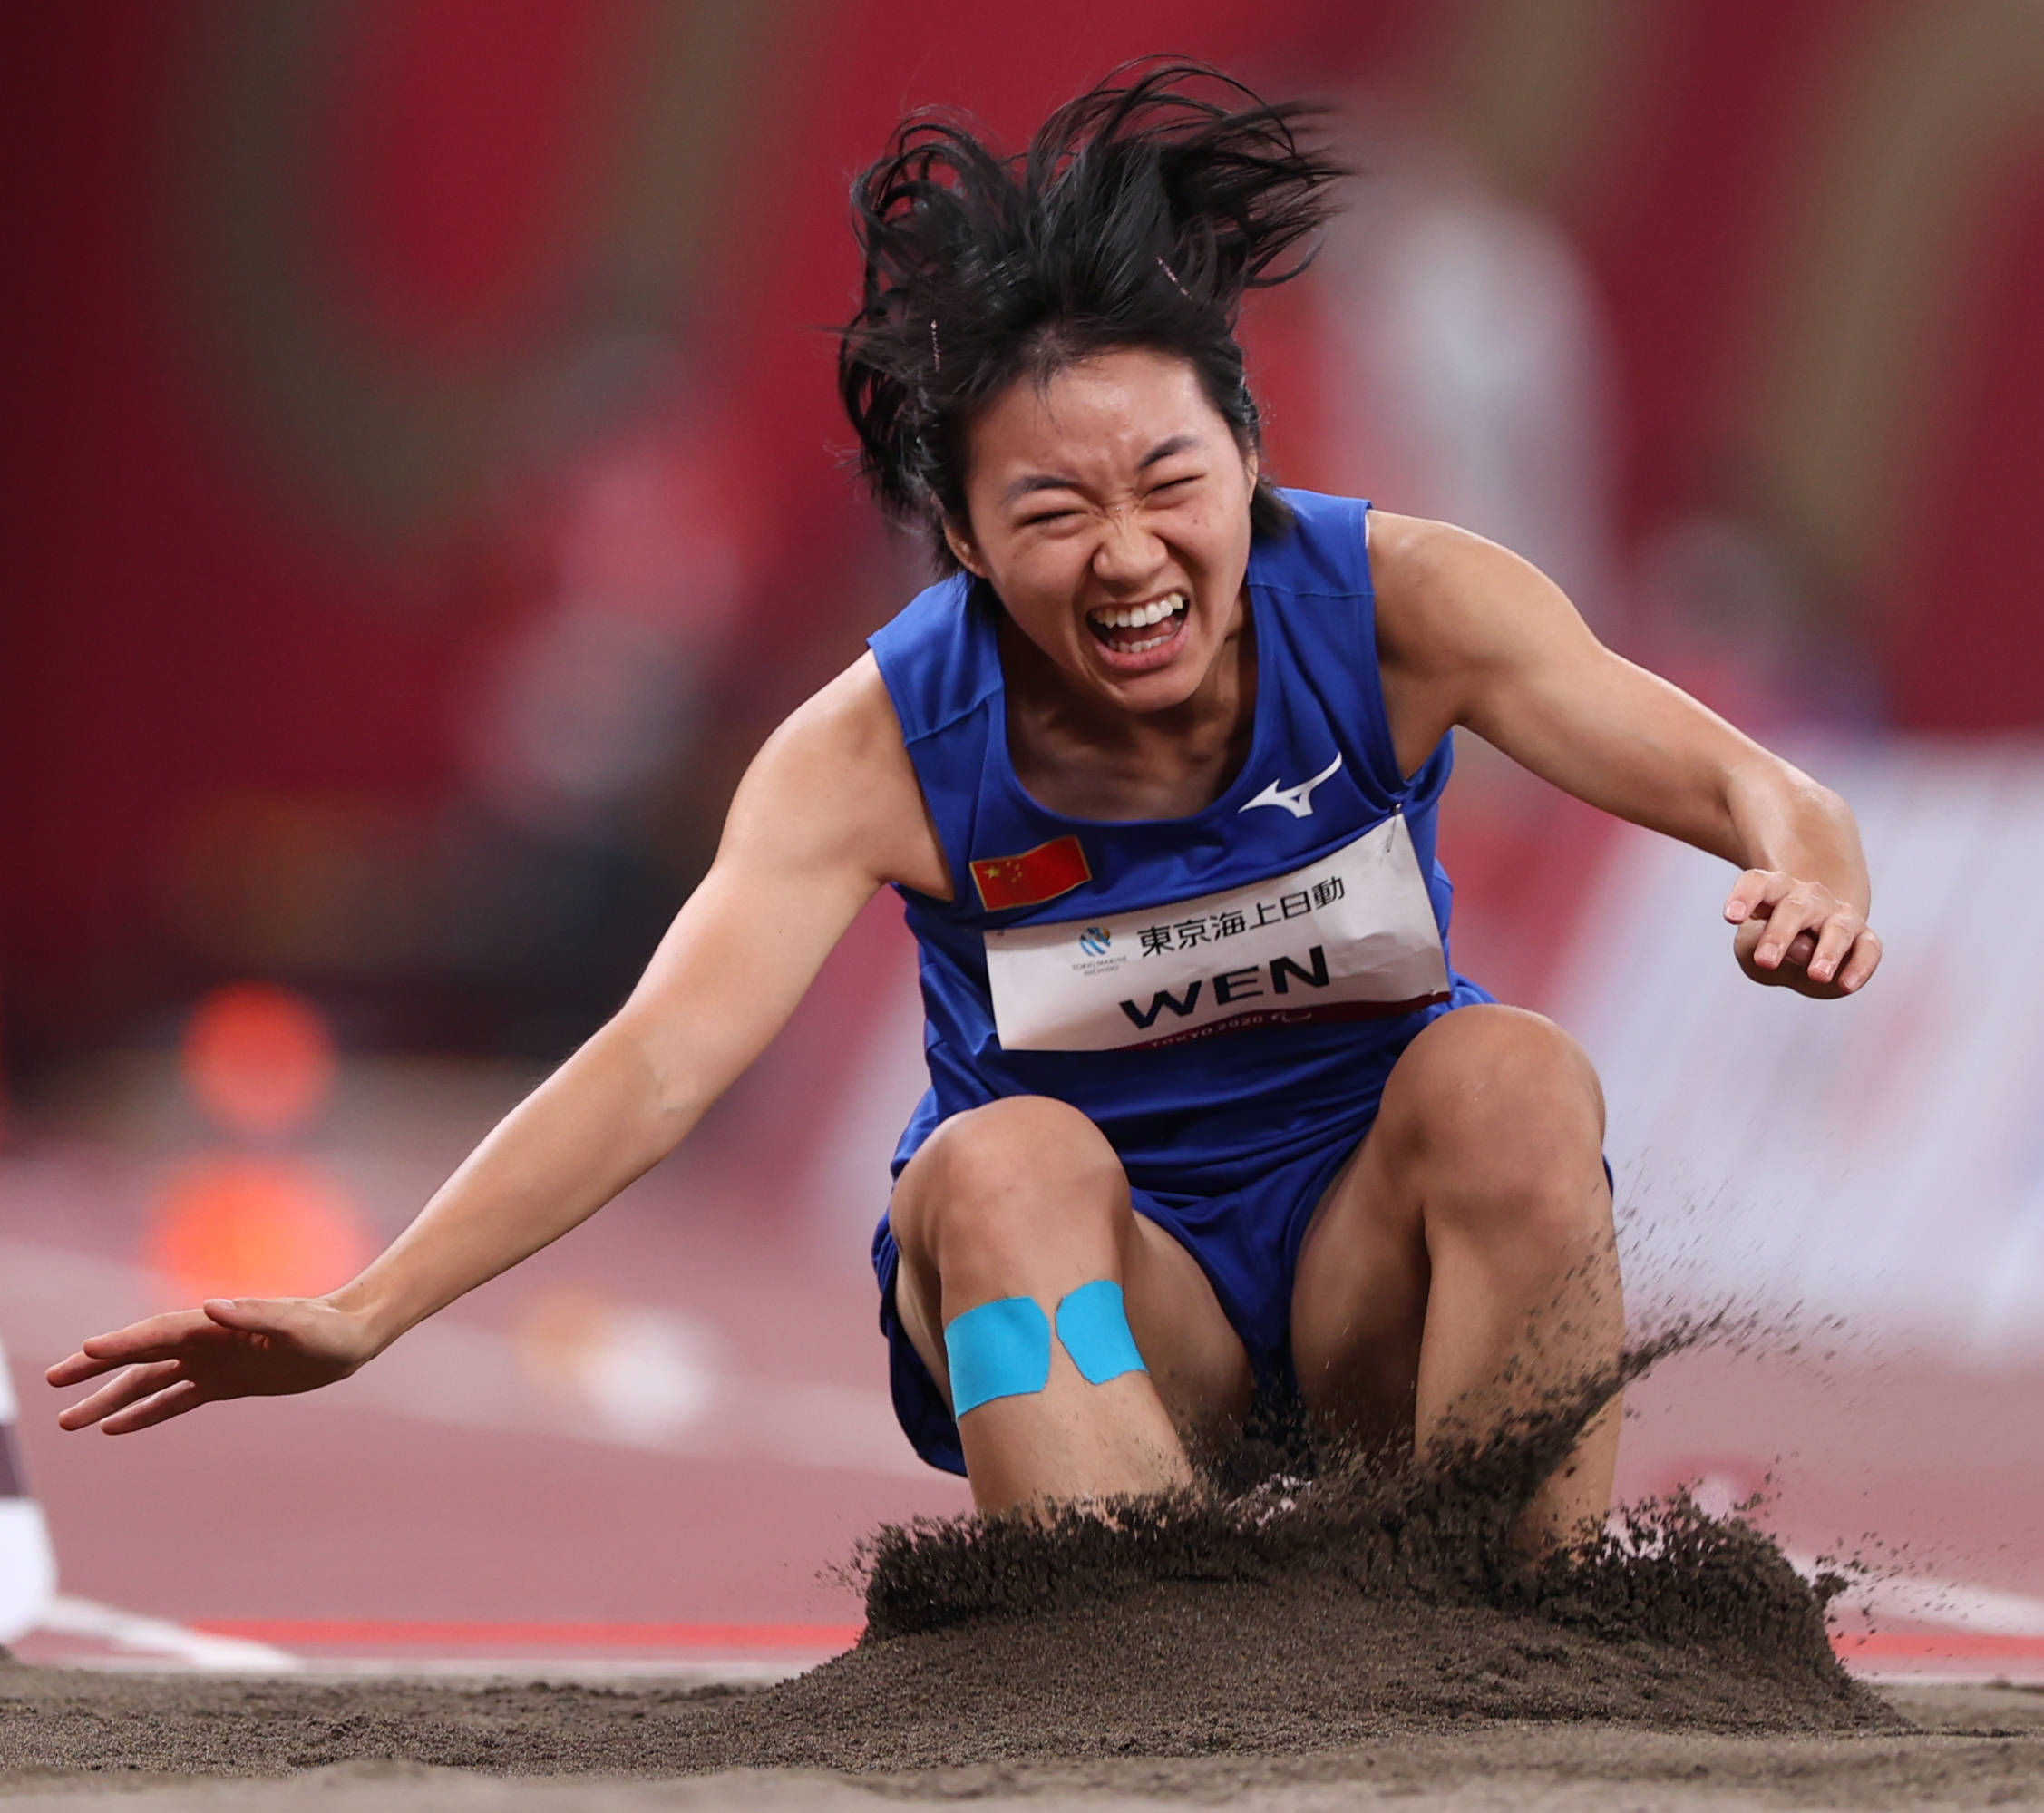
[{"xmin": 0, "ymin": 1114, "xmax": 2044, "ymax": 1674}]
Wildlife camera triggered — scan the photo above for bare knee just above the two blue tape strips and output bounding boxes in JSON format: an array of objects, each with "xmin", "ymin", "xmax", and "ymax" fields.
[{"xmin": 889, "ymin": 1096, "xmax": 1128, "ymax": 1272}]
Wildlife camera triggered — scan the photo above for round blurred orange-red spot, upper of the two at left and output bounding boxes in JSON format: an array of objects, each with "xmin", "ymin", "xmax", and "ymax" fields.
[{"xmin": 178, "ymin": 981, "xmax": 336, "ymax": 1135}]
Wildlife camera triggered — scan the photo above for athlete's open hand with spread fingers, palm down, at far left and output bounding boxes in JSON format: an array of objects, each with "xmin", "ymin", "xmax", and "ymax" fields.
[{"xmin": 45, "ymin": 1296, "xmax": 376, "ymax": 1435}]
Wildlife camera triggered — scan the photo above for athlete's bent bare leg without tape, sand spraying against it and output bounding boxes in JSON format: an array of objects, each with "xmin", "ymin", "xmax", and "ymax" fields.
[{"xmin": 1292, "ymin": 1006, "xmax": 1625, "ymax": 1544}]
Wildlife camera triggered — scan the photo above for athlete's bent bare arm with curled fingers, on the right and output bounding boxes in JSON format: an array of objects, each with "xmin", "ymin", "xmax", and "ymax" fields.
[{"xmin": 1369, "ymin": 513, "xmax": 1881, "ymax": 998}]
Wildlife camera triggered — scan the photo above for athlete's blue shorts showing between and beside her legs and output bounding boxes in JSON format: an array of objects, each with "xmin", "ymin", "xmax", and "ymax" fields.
[{"xmin": 872, "ymin": 1091, "xmax": 1376, "ymax": 1474}]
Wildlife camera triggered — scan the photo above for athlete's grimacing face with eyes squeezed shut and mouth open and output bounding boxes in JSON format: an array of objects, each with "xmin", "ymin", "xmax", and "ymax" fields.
[{"xmin": 947, "ymin": 352, "xmax": 1257, "ymax": 711}]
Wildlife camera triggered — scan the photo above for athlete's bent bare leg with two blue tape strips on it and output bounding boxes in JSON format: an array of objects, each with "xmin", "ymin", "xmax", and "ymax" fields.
[{"xmin": 889, "ymin": 1096, "xmax": 1253, "ymax": 1510}]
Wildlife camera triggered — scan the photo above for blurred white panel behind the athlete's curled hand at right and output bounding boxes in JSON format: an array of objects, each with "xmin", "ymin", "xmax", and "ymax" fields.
[{"xmin": 1558, "ymin": 738, "xmax": 2044, "ymax": 1368}]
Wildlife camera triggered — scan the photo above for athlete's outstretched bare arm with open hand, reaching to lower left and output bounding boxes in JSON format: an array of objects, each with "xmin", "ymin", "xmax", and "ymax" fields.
[{"xmin": 49, "ymin": 656, "xmax": 949, "ymax": 1435}]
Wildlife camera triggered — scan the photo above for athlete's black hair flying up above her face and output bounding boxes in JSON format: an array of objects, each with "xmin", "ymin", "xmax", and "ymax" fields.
[{"xmin": 838, "ymin": 59, "xmax": 1347, "ymax": 572}]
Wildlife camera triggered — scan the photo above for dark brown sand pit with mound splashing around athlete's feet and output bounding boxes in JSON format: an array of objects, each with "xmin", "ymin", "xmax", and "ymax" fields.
[{"xmin": 0, "ymin": 1365, "xmax": 2044, "ymax": 1808}]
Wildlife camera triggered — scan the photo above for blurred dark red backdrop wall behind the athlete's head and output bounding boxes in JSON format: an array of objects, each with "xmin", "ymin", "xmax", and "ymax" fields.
[{"xmin": 0, "ymin": 0, "xmax": 2044, "ymax": 1079}]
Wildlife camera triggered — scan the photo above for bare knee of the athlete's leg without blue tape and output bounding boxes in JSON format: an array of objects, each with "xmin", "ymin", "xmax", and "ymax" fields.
[{"xmin": 1379, "ymin": 1006, "xmax": 1611, "ymax": 1244}]
